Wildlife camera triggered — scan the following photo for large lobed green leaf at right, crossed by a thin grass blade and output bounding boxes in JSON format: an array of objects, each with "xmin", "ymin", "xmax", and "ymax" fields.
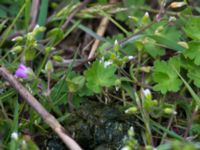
[{"xmin": 153, "ymin": 57, "xmax": 182, "ymax": 94}]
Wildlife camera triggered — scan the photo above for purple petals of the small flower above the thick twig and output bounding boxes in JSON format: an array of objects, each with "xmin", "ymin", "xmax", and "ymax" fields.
[{"xmin": 15, "ymin": 64, "xmax": 30, "ymax": 78}]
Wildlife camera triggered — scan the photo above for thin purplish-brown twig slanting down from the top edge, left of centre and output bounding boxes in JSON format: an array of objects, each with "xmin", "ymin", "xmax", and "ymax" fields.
[{"xmin": 62, "ymin": 0, "xmax": 91, "ymax": 30}]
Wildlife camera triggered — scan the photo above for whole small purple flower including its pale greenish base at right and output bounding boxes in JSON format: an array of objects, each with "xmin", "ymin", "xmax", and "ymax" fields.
[{"xmin": 15, "ymin": 64, "xmax": 34, "ymax": 79}]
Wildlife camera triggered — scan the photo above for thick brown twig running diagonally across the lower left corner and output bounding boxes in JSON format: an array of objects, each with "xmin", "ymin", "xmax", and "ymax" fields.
[{"xmin": 0, "ymin": 66, "xmax": 82, "ymax": 150}]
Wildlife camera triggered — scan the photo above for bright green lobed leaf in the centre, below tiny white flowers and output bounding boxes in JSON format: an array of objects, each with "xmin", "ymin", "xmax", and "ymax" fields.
[{"xmin": 85, "ymin": 61, "xmax": 117, "ymax": 93}]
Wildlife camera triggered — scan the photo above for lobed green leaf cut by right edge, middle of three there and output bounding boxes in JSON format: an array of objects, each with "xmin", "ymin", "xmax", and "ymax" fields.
[{"xmin": 183, "ymin": 41, "xmax": 200, "ymax": 65}]
